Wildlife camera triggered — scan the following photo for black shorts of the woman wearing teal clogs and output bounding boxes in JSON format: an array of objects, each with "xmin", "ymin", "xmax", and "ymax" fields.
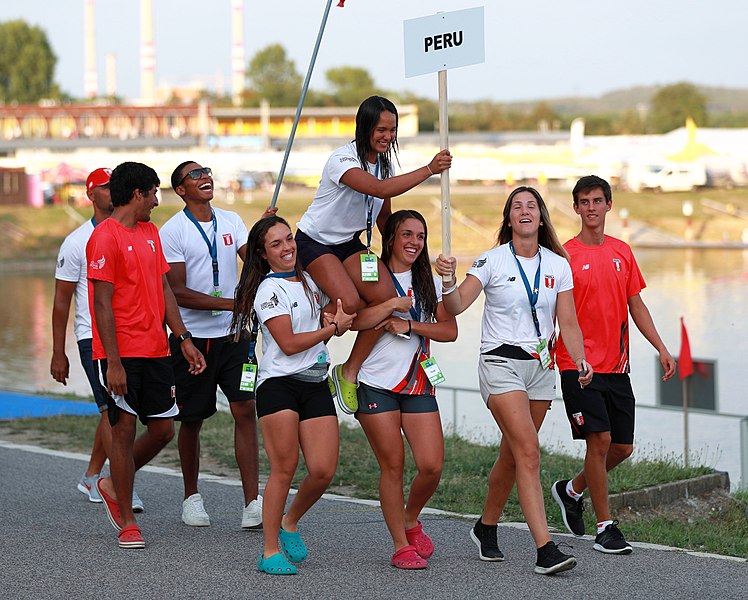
[{"xmin": 257, "ymin": 376, "xmax": 337, "ymax": 421}]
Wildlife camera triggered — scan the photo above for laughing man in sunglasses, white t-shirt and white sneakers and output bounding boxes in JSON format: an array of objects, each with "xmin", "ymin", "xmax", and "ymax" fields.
[{"xmin": 161, "ymin": 161, "xmax": 276, "ymax": 529}]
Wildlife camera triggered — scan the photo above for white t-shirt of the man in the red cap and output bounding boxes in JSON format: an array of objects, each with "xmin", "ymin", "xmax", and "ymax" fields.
[{"xmin": 55, "ymin": 219, "xmax": 94, "ymax": 341}]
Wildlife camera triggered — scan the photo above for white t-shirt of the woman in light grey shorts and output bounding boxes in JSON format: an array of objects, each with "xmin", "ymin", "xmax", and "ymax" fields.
[{"xmin": 468, "ymin": 244, "xmax": 574, "ymax": 355}]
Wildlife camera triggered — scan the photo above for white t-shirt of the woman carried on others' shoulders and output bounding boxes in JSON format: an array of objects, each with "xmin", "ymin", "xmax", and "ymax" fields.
[{"xmin": 296, "ymin": 142, "xmax": 394, "ymax": 246}]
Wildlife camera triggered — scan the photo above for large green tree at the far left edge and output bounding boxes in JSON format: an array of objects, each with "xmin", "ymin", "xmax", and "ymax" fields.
[{"xmin": 0, "ymin": 20, "xmax": 59, "ymax": 102}]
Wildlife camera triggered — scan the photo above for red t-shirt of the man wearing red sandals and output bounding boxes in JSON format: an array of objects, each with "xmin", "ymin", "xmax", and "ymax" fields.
[{"xmin": 86, "ymin": 219, "xmax": 169, "ymax": 360}]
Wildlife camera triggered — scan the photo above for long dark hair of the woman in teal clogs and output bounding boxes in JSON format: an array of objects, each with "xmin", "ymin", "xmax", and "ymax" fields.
[{"xmin": 230, "ymin": 216, "xmax": 316, "ymax": 335}]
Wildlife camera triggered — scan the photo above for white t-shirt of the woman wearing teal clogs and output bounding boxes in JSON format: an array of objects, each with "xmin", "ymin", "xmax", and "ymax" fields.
[{"xmin": 254, "ymin": 273, "xmax": 330, "ymax": 388}]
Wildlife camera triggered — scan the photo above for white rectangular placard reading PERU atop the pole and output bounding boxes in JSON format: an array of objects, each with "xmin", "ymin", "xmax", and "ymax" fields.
[{"xmin": 403, "ymin": 6, "xmax": 486, "ymax": 77}]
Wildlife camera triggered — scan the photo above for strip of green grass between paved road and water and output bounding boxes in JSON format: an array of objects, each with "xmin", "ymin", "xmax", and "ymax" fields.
[{"xmin": 0, "ymin": 413, "xmax": 748, "ymax": 558}]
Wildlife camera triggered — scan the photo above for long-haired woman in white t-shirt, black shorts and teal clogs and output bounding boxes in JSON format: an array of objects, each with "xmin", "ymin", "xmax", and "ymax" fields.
[{"xmin": 232, "ymin": 216, "xmax": 355, "ymax": 575}]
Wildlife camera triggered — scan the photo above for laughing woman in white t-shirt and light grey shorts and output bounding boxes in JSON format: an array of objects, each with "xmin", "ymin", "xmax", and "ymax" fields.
[{"xmin": 436, "ymin": 187, "xmax": 592, "ymax": 575}]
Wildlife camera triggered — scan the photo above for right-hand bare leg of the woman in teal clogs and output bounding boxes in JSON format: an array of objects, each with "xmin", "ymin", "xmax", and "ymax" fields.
[{"xmin": 282, "ymin": 416, "xmax": 340, "ymax": 531}]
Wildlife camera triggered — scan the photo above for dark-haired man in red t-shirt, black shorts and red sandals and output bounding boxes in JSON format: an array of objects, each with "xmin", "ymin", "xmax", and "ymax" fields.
[{"xmin": 86, "ymin": 162, "xmax": 205, "ymax": 548}]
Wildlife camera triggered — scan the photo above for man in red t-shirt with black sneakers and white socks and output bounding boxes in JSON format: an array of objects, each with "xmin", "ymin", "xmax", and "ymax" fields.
[{"xmin": 551, "ymin": 175, "xmax": 675, "ymax": 554}]
